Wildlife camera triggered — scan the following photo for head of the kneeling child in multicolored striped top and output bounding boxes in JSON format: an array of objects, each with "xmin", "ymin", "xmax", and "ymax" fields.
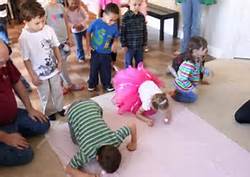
[{"xmin": 188, "ymin": 36, "xmax": 207, "ymax": 60}]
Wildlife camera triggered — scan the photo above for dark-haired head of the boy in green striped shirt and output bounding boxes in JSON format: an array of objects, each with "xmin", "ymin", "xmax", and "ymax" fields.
[{"xmin": 97, "ymin": 145, "xmax": 122, "ymax": 173}]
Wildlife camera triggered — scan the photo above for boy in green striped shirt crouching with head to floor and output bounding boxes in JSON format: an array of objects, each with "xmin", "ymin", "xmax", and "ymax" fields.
[{"xmin": 66, "ymin": 100, "xmax": 137, "ymax": 177}]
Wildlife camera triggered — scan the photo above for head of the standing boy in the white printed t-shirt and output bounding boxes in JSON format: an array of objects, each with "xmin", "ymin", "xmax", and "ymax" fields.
[{"xmin": 21, "ymin": 1, "xmax": 45, "ymax": 32}]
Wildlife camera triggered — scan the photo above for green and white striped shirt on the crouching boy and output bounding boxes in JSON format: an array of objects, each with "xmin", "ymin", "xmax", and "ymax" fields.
[{"xmin": 67, "ymin": 100, "xmax": 130, "ymax": 168}]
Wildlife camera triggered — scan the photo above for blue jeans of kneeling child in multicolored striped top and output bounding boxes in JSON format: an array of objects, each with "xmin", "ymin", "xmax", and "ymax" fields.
[{"xmin": 173, "ymin": 91, "xmax": 198, "ymax": 103}]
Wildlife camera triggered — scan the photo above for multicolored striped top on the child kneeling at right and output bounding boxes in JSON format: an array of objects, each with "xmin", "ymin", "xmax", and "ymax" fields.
[{"xmin": 175, "ymin": 61, "xmax": 202, "ymax": 92}]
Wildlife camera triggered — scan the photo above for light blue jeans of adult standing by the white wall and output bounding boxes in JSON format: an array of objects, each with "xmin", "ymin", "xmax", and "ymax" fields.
[{"xmin": 181, "ymin": 0, "xmax": 201, "ymax": 53}]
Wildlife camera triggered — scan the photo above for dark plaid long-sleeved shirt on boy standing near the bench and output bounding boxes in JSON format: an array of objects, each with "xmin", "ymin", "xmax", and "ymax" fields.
[{"xmin": 121, "ymin": 10, "xmax": 148, "ymax": 49}]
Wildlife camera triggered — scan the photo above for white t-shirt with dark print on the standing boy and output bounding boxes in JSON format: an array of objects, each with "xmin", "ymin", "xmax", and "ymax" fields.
[{"xmin": 19, "ymin": 25, "xmax": 60, "ymax": 80}]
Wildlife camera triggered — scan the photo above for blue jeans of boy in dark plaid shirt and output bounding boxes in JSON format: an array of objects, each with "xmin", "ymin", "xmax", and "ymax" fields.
[{"xmin": 125, "ymin": 47, "xmax": 143, "ymax": 68}]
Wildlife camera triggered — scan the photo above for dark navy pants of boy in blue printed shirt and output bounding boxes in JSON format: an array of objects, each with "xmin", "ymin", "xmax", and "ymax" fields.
[{"xmin": 88, "ymin": 51, "xmax": 112, "ymax": 89}]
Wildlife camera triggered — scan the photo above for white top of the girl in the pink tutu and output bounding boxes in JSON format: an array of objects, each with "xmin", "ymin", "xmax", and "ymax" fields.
[{"xmin": 138, "ymin": 80, "xmax": 162, "ymax": 111}]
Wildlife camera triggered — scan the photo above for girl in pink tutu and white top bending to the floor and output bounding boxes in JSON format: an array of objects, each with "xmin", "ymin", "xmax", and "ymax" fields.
[{"xmin": 113, "ymin": 63, "xmax": 171, "ymax": 126}]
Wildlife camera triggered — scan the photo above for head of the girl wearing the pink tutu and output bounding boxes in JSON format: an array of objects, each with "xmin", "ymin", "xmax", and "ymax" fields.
[{"xmin": 151, "ymin": 93, "xmax": 168, "ymax": 110}]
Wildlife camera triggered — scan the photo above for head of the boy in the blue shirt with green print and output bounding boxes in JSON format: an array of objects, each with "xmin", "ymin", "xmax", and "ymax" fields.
[{"xmin": 103, "ymin": 3, "xmax": 120, "ymax": 25}]
